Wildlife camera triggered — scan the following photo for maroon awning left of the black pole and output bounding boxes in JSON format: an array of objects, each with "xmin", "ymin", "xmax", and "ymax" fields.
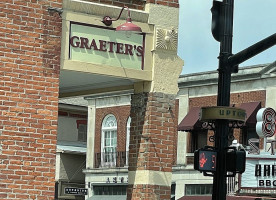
[{"xmin": 178, "ymin": 107, "xmax": 201, "ymax": 131}]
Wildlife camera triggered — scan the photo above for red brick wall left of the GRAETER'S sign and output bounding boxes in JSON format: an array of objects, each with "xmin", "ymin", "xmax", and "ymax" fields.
[{"xmin": 0, "ymin": 0, "xmax": 62, "ymax": 200}]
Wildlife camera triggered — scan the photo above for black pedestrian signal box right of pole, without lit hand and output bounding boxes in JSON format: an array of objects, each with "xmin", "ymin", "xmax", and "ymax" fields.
[{"xmin": 226, "ymin": 148, "xmax": 246, "ymax": 174}]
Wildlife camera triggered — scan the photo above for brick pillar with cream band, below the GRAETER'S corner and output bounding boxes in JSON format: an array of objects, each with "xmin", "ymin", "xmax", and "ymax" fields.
[{"xmin": 127, "ymin": 93, "xmax": 176, "ymax": 200}]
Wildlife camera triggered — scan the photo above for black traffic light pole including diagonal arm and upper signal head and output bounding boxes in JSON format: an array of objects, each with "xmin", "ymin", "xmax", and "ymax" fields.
[{"xmin": 212, "ymin": 0, "xmax": 276, "ymax": 200}]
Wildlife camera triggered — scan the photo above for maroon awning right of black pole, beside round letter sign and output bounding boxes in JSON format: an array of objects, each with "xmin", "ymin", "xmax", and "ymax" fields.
[{"xmin": 240, "ymin": 102, "xmax": 261, "ymax": 124}]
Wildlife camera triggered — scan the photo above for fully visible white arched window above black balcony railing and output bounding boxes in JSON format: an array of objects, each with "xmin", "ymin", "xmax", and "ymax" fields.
[{"xmin": 101, "ymin": 115, "xmax": 117, "ymax": 166}]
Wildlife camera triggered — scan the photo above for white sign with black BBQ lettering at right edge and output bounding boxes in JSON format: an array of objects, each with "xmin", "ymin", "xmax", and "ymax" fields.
[{"xmin": 241, "ymin": 155, "xmax": 276, "ymax": 189}]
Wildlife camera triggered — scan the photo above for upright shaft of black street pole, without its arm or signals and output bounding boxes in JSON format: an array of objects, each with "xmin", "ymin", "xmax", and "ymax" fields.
[{"xmin": 212, "ymin": 0, "xmax": 234, "ymax": 200}]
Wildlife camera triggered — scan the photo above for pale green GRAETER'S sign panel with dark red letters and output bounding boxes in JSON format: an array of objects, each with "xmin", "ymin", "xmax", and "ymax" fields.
[{"xmin": 69, "ymin": 22, "xmax": 145, "ymax": 70}]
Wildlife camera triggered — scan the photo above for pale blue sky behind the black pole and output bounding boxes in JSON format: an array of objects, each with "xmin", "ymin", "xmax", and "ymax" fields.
[{"xmin": 178, "ymin": 0, "xmax": 276, "ymax": 74}]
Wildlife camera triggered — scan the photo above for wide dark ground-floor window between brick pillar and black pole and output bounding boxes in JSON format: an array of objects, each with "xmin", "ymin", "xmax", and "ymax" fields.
[{"xmin": 185, "ymin": 184, "xmax": 213, "ymax": 196}]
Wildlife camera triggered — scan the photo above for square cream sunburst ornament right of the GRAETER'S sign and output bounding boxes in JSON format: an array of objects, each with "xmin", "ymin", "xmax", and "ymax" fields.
[{"xmin": 156, "ymin": 28, "xmax": 178, "ymax": 51}]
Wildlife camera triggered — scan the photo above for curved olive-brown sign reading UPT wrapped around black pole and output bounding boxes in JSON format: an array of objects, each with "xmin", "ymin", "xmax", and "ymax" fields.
[{"xmin": 200, "ymin": 106, "xmax": 246, "ymax": 121}]
